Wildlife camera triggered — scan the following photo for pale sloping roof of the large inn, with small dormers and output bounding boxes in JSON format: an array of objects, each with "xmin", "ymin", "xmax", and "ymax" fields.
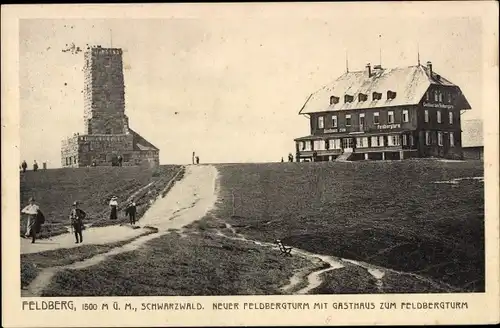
[{"xmin": 299, "ymin": 65, "xmax": 470, "ymax": 114}]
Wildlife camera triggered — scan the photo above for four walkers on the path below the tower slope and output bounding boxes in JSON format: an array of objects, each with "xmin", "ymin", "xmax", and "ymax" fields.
[{"xmin": 21, "ymin": 196, "xmax": 137, "ymax": 244}]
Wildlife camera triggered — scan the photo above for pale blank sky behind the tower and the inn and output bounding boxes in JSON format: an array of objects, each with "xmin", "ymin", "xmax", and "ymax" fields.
[{"xmin": 19, "ymin": 5, "xmax": 484, "ymax": 167}]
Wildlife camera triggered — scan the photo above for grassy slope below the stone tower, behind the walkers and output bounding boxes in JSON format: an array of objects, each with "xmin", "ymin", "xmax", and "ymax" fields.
[{"xmin": 20, "ymin": 165, "xmax": 181, "ymax": 238}]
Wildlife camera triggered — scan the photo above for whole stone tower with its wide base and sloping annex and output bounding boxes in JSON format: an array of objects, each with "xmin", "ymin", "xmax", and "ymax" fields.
[{"xmin": 61, "ymin": 46, "xmax": 160, "ymax": 167}]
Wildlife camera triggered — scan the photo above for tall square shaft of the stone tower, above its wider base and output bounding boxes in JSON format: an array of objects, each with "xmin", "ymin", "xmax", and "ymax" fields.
[{"xmin": 84, "ymin": 47, "xmax": 128, "ymax": 134}]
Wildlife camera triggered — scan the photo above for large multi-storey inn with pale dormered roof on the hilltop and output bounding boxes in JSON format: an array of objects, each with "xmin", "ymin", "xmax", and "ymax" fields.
[{"xmin": 295, "ymin": 62, "xmax": 470, "ymax": 161}]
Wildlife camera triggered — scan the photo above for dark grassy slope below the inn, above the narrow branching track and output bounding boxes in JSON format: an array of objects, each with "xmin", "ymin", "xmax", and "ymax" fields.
[{"xmin": 216, "ymin": 159, "xmax": 485, "ymax": 291}]
